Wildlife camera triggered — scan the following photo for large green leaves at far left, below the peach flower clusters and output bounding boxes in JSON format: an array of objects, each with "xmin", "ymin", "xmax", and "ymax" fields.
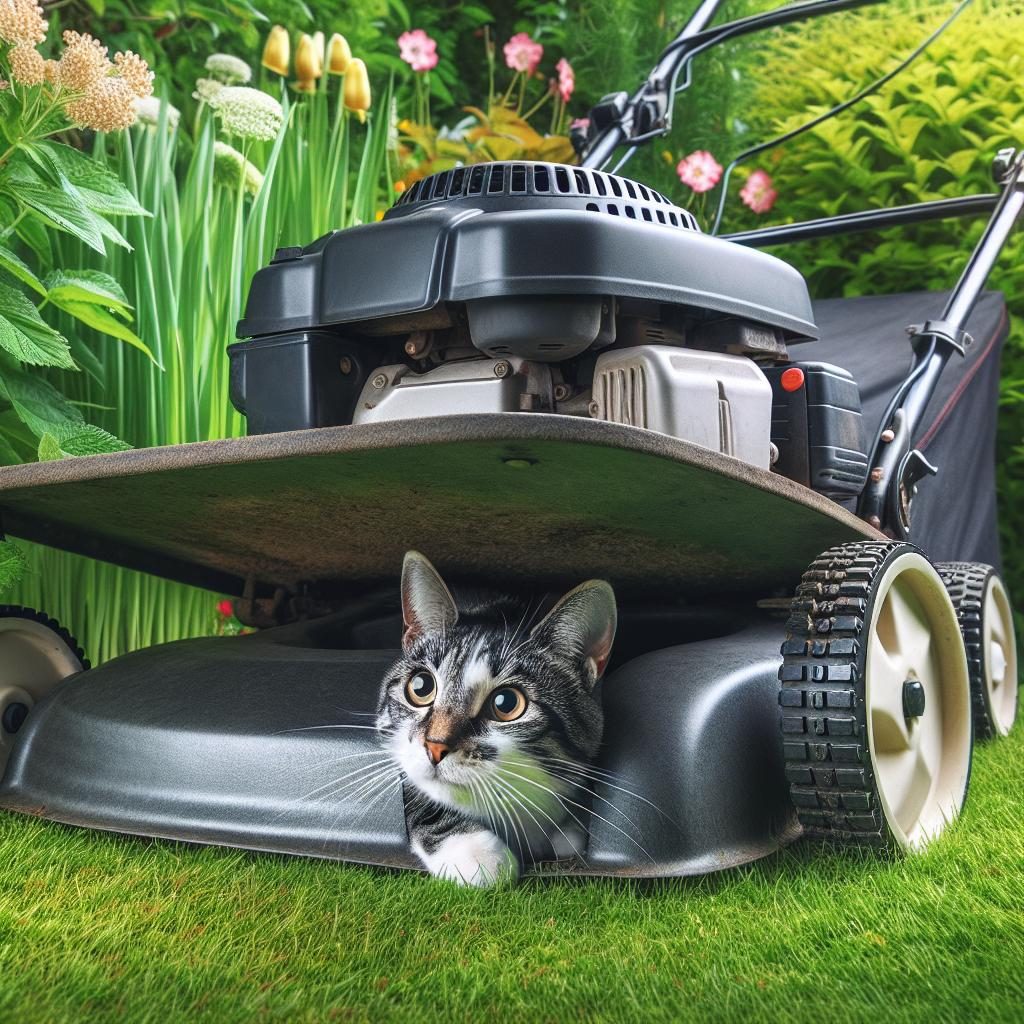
[{"xmin": 0, "ymin": 47, "xmax": 148, "ymax": 471}]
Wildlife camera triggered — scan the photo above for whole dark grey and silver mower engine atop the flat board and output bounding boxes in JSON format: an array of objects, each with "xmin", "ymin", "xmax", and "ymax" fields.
[{"xmin": 228, "ymin": 163, "xmax": 867, "ymax": 495}]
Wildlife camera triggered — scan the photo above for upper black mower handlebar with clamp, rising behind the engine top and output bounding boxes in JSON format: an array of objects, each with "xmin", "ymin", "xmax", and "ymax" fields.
[{"xmin": 579, "ymin": 0, "xmax": 885, "ymax": 169}]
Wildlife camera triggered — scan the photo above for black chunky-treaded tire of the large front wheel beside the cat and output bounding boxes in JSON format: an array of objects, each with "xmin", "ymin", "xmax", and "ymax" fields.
[{"xmin": 779, "ymin": 541, "xmax": 972, "ymax": 851}]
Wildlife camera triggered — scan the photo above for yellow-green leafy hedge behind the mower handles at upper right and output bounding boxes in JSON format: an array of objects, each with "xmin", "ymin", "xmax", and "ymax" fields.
[{"xmin": 725, "ymin": 0, "xmax": 1024, "ymax": 595}]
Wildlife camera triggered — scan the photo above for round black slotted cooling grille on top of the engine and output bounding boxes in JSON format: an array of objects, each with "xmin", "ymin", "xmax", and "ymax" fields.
[{"xmin": 391, "ymin": 162, "xmax": 699, "ymax": 230}]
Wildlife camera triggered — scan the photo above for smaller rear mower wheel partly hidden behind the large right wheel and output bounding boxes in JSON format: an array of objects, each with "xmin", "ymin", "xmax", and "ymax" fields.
[{"xmin": 935, "ymin": 562, "xmax": 1017, "ymax": 739}]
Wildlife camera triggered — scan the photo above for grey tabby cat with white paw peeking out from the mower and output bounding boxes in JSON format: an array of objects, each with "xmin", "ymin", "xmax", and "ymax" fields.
[{"xmin": 376, "ymin": 551, "xmax": 616, "ymax": 887}]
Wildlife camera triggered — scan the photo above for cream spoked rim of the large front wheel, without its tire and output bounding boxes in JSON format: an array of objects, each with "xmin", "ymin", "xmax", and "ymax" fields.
[{"xmin": 864, "ymin": 552, "xmax": 972, "ymax": 850}]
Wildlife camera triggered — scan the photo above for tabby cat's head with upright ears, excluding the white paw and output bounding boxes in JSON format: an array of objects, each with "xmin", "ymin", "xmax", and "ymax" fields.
[{"xmin": 378, "ymin": 552, "xmax": 615, "ymax": 820}]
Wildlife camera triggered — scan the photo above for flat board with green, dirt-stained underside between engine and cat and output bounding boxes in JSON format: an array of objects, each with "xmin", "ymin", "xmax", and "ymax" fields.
[{"xmin": 0, "ymin": 414, "xmax": 881, "ymax": 600}]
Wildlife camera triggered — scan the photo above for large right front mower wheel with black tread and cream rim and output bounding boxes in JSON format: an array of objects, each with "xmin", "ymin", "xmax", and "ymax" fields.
[{"xmin": 779, "ymin": 541, "xmax": 973, "ymax": 851}]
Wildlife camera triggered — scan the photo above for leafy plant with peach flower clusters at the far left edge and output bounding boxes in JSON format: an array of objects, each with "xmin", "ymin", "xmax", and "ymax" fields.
[{"xmin": 0, "ymin": 8, "xmax": 160, "ymax": 588}]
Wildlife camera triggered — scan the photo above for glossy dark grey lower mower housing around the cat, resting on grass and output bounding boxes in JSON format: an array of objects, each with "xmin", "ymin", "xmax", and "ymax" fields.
[{"xmin": 0, "ymin": 620, "xmax": 799, "ymax": 877}]
